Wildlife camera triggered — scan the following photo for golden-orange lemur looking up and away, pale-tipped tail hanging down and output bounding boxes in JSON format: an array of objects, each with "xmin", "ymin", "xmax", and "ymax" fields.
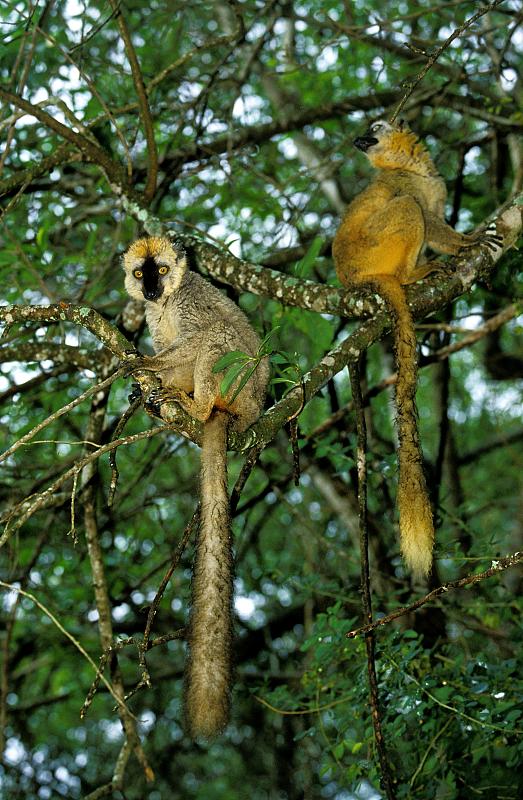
[{"xmin": 332, "ymin": 120, "xmax": 498, "ymax": 577}]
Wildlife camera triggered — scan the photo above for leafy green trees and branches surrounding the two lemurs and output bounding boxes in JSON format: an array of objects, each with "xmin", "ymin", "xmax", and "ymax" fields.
[{"xmin": 0, "ymin": 0, "xmax": 523, "ymax": 800}]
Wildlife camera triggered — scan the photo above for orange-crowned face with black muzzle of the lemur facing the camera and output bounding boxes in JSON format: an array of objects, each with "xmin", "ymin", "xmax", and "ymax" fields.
[{"xmin": 123, "ymin": 236, "xmax": 187, "ymax": 303}]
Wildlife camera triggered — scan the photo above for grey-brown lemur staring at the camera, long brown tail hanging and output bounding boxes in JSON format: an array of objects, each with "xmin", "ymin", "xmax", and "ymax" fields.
[{"xmin": 123, "ymin": 238, "xmax": 269, "ymax": 738}]
